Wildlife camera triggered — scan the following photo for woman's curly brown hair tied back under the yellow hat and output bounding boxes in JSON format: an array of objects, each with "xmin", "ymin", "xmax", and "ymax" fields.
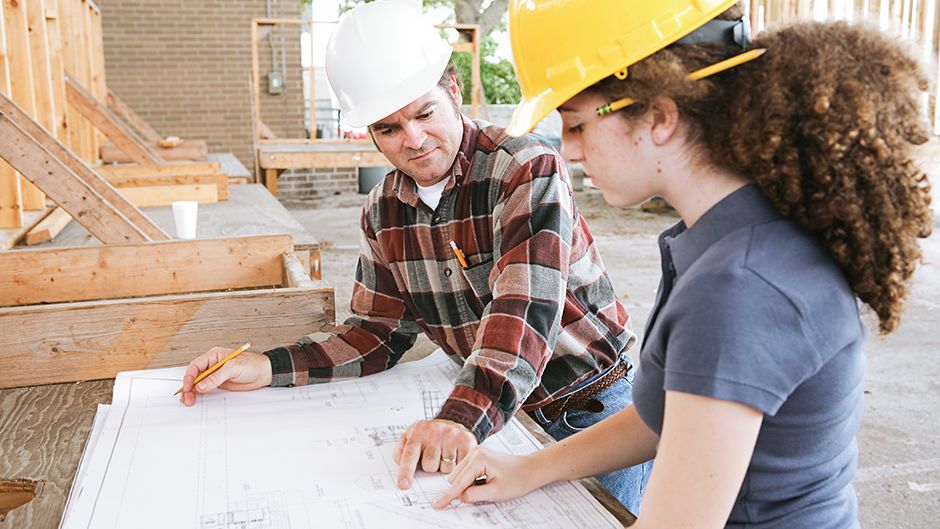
[{"xmin": 588, "ymin": 18, "xmax": 932, "ymax": 334}]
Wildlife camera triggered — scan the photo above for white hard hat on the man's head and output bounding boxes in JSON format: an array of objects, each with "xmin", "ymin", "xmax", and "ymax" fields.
[{"xmin": 326, "ymin": 0, "xmax": 453, "ymax": 127}]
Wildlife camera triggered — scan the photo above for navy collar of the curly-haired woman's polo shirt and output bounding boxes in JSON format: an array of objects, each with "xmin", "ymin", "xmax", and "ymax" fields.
[{"xmin": 669, "ymin": 184, "xmax": 780, "ymax": 276}]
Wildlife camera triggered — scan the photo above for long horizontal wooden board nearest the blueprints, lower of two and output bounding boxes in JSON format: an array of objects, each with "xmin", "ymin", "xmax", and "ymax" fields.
[{"xmin": 0, "ymin": 286, "xmax": 335, "ymax": 387}]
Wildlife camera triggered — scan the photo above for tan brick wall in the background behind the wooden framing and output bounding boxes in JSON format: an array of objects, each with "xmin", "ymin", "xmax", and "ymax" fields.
[{"xmin": 97, "ymin": 0, "xmax": 357, "ymax": 198}]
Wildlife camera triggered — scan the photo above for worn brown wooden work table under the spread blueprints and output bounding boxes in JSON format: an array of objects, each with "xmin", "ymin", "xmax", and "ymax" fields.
[{"xmin": 0, "ymin": 380, "xmax": 634, "ymax": 529}]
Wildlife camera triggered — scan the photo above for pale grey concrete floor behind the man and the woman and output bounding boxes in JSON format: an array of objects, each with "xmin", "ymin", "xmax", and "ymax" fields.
[{"xmin": 287, "ymin": 189, "xmax": 940, "ymax": 529}]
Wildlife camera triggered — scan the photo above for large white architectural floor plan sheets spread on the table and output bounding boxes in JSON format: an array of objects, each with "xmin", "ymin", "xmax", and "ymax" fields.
[{"xmin": 62, "ymin": 352, "xmax": 620, "ymax": 529}]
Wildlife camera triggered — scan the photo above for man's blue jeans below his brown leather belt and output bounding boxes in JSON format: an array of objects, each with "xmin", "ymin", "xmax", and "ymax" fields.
[{"xmin": 532, "ymin": 355, "xmax": 653, "ymax": 515}]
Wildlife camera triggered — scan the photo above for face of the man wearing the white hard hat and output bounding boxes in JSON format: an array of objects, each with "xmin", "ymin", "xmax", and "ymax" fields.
[{"xmin": 369, "ymin": 77, "xmax": 463, "ymax": 186}]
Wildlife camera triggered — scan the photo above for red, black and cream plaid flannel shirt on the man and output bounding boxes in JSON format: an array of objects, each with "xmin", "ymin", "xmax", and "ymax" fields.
[{"xmin": 265, "ymin": 118, "xmax": 636, "ymax": 441}]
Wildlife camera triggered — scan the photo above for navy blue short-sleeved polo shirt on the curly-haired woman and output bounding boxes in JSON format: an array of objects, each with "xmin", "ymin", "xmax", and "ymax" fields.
[{"xmin": 633, "ymin": 185, "xmax": 865, "ymax": 529}]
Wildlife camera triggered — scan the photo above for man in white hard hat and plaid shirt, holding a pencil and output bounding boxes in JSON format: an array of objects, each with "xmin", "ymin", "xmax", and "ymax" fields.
[{"xmin": 182, "ymin": 1, "xmax": 649, "ymax": 512}]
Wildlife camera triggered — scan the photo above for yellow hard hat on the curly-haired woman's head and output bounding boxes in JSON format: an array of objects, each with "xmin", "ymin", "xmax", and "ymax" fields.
[{"xmin": 507, "ymin": 0, "xmax": 738, "ymax": 136}]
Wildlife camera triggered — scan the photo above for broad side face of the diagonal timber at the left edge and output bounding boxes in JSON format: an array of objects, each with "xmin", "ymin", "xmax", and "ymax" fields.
[{"xmin": 0, "ymin": 102, "xmax": 147, "ymax": 244}]
